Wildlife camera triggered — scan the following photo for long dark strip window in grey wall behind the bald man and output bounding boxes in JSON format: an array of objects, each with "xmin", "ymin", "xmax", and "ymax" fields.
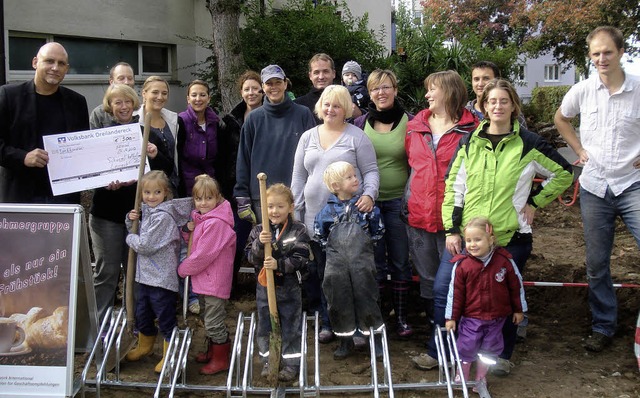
[{"xmin": 9, "ymin": 32, "xmax": 172, "ymax": 81}]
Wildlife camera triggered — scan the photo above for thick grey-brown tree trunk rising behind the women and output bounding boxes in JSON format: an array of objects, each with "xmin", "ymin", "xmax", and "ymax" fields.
[{"xmin": 207, "ymin": 0, "xmax": 246, "ymax": 113}]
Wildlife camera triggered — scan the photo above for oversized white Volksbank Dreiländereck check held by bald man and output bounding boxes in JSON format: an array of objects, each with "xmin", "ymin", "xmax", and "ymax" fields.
[{"xmin": 43, "ymin": 123, "xmax": 149, "ymax": 195}]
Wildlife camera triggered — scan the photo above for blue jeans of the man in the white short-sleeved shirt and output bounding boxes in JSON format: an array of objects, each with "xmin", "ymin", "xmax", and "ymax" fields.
[{"xmin": 580, "ymin": 182, "xmax": 640, "ymax": 337}]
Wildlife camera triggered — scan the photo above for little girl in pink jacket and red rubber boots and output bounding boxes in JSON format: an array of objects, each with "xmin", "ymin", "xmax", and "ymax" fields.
[{"xmin": 178, "ymin": 174, "xmax": 236, "ymax": 375}]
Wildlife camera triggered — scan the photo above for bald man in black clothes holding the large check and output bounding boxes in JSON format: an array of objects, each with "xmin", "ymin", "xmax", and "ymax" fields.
[{"xmin": 0, "ymin": 42, "xmax": 89, "ymax": 204}]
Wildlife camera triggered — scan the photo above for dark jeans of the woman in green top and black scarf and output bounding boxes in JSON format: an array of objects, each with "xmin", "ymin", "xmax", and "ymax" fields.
[{"xmin": 374, "ymin": 198, "xmax": 412, "ymax": 283}]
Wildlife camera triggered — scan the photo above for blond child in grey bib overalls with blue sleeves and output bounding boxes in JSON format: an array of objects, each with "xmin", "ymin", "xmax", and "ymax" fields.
[{"xmin": 314, "ymin": 162, "xmax": 384, "ymax": 359}]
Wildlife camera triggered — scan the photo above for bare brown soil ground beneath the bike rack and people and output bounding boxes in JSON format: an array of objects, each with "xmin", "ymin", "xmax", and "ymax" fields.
[{"xmin": 76, "ymin": 201, "xmax": 640, "ymax": 398}]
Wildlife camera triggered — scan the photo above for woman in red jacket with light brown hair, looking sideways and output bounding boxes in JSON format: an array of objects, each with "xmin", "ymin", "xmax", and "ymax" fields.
[{"xmin": 402, "ymin": 70, "xmax": 478, "ymax": 348}]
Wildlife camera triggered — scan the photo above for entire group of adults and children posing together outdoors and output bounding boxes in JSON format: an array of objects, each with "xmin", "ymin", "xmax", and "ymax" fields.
[{"xmin": 0, "ymin": 27, "xmax": 640, "ymax": 388}]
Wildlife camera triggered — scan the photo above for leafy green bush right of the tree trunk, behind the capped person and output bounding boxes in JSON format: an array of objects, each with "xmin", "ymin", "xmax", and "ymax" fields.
[{"xmin": 240, "ymin": 0, "xmax": 384, "ymax": 96}]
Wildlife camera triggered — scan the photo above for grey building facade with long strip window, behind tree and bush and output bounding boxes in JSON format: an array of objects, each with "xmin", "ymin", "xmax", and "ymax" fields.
[{"xmin": 3, "ymin": 0, "xmax": 391, "ymax": 111}]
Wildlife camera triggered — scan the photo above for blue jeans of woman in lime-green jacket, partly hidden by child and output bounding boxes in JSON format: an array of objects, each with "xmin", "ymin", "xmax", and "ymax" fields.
[{"xmin": 427, "ymin": 233, "xmax": 533, "ymax": 359}]
